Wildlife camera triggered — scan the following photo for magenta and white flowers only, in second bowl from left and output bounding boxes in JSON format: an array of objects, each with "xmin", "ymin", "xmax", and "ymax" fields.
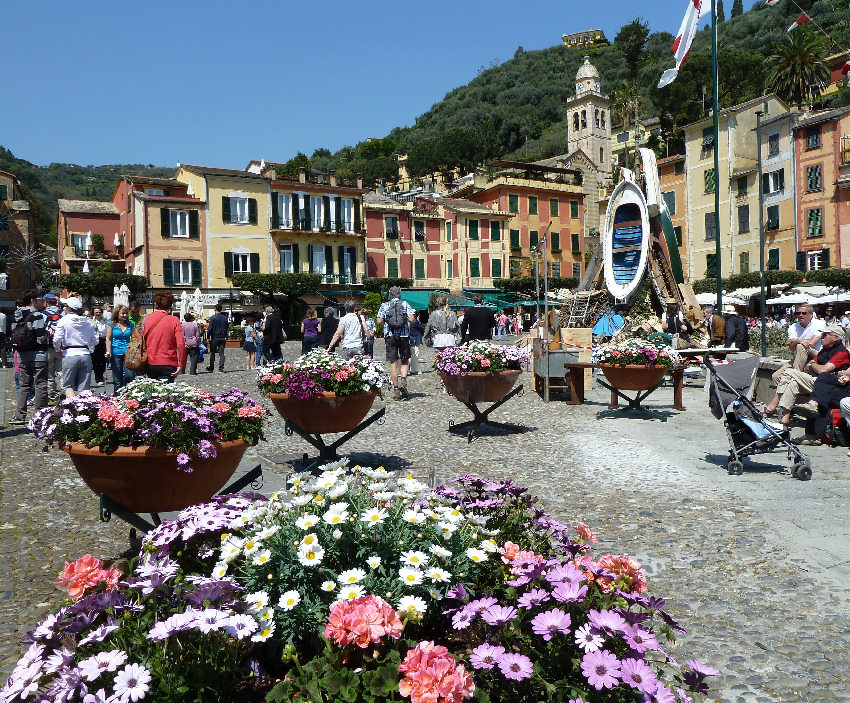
[{"xmin": 258, "ymin": 349, "xmax": 392, "ymax": 400}]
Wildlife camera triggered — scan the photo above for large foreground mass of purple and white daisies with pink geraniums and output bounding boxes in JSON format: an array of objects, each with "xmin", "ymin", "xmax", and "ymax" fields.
[{"xmin": 2, "ymin": 463, "xmax": 717, "ymax": 703}]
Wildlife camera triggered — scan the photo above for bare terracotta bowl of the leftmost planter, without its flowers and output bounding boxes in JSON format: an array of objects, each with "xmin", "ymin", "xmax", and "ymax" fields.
[{"xmin": 62, "ymin": 439, "xmax": 248, "ymax": 513}]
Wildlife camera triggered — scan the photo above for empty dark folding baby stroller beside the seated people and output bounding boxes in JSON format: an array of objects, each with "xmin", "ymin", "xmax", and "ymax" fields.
[{"xmin": 703, "ymin": 355, "xmax": 812, "ymax": 481}]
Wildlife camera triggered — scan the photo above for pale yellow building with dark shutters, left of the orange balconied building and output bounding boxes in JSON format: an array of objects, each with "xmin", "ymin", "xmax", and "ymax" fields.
[{"xmin": 176, "ymin": 164, "xmax": 277, "ymax": 289}]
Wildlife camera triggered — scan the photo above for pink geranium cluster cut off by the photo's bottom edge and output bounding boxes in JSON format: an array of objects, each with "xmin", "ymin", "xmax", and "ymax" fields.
[{"xmin": 398, "ymin": 642, "xmax": 475, "ymax": 703}]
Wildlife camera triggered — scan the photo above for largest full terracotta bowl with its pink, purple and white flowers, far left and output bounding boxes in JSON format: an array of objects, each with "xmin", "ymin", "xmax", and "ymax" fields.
[{"xmin": 29, "ymin": 378, "xmax": 266, "ymax": 513}]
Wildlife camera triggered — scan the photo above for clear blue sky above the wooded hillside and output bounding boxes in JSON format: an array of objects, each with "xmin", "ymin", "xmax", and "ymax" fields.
[{"xmin": 0, "ymin": 0, "xmax": 754, "ymax": 168}]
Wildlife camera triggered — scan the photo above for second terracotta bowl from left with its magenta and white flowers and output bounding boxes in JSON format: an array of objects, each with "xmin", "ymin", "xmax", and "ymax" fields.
[{"xmin": 258, "ymin": 349, "xmax": 392, "ymax": 434}]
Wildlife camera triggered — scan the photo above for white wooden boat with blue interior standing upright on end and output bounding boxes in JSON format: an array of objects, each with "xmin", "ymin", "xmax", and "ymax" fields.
[{"xmin": 602, "ymin": 172, "xmax": 652, "ymax": 303}]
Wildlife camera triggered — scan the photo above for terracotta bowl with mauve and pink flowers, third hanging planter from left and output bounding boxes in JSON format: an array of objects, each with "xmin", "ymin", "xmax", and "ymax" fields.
[{"xmin": 434, "ymin": 341, "xmax": 529, "ymax": 403}]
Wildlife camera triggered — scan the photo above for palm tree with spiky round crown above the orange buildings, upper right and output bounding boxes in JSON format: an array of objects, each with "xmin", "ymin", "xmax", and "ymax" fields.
[{"xmin": 767, "ymin": 27, "xmax": 830, "ymax": 107}]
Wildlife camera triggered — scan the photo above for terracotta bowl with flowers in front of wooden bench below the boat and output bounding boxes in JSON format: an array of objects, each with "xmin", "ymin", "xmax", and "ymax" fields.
[{"xmin": 591, "ymin": 339, "xmax": 679, "ymax": 391}]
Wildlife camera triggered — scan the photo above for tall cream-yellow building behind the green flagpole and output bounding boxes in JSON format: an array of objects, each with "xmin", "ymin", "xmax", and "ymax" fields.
[{"xmin": 684, "ymin": 95, "xmax": 793, "ymax": 281}]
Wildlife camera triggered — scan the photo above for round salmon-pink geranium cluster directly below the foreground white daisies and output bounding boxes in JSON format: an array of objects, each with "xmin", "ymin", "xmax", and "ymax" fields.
[{"xmin": 325, "ymin": 596, "xmax": 402, "ymax": 649}]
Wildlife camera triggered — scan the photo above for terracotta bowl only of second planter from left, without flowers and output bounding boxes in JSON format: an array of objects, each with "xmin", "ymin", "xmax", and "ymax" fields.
[{"xmin": 268, "ymin": 391, "xmax": 377, "ymax": 434}]
